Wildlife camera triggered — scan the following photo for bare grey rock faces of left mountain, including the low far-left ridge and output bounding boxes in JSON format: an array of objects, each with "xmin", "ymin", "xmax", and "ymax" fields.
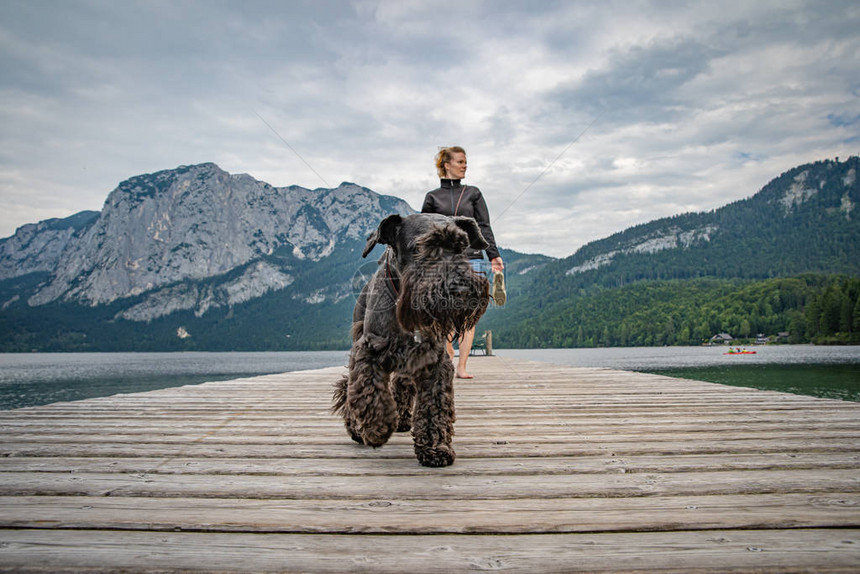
[{"xmin": 0, "ymin": 163, "xmax": 412, "ymax": 321}]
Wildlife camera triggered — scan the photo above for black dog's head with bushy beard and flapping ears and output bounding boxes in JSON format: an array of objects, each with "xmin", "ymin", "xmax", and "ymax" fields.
[{"xmin": 362, "ymin": 213, "xmax": 490, "ymax": 336}]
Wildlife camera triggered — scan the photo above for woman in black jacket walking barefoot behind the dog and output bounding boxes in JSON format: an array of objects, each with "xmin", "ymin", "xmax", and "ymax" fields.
[{"xmin": 421, "ymin": 146, "xmax": 505, "ymax": 379}]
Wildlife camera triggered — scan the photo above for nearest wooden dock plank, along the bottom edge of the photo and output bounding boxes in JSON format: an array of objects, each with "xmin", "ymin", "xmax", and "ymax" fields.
[{"xmin": 0, "ymin": 529, "xmax": 860, "ymax": 574}]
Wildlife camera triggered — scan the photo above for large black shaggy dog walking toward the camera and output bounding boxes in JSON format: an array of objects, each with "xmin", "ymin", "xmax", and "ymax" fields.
[{"xmin": 332, "ymin": 213, "xmax": 490, "ymax": 466}]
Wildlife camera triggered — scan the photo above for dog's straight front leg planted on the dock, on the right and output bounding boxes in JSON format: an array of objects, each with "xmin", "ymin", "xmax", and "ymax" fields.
[{"xmin": 412, "ymin": 344, "xmax": 456, "ymax": 466}]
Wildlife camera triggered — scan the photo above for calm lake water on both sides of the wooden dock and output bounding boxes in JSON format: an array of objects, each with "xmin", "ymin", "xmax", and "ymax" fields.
[{"xmin": 0, "ymin": 345, "xmax": 860, "ymax": 409}]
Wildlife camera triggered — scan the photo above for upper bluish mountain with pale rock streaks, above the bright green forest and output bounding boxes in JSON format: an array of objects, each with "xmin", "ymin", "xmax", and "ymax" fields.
[{"xmin": 564, "ymin": 156, "xmax": 860, "ymax": 284}]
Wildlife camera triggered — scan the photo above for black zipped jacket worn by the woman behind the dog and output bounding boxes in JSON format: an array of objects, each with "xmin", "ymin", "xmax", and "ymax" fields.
[{"xmin": 421, "ymin": 179, "xmax": 499, "ymax": 261}]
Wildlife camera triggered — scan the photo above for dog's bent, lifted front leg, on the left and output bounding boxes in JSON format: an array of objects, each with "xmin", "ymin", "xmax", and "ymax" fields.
[{"xmin": 346, "ymin": 337, "xmax": 397, "ymax": 447}]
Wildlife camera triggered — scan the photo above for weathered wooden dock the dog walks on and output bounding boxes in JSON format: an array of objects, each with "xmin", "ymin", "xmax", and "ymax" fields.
[{"xmin": 0, "ymin": 357, "xmax": 860, "ymax": 572}]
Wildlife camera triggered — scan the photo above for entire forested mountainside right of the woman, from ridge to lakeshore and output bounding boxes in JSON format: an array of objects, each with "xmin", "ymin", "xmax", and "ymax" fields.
[{"xmin": 480, "ymin": 157, "xmax": 860, "ymax": 348}]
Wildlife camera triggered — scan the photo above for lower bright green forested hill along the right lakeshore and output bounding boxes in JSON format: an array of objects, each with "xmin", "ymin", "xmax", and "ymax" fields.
[{"xmin": 488, "ymin": 275, "xmax": 860, "ymax": 348}]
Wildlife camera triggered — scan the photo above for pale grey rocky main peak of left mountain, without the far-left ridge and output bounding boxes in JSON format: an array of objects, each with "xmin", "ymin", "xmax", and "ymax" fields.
[{"xmin": 15, "ymin": 163, "xmax": 412, "ymax": 312}]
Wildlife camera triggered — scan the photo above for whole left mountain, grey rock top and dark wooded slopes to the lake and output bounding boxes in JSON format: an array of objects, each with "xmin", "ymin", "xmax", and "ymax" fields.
[{"xmin": 0, "ymin": 163, "xmax": 550, "ymax": 351}]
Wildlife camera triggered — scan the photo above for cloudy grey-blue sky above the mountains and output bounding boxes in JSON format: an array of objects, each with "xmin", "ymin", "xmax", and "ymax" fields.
[{"xmin": 0, "ymin": 0, "xmax": 860, "ymax": 256}]
